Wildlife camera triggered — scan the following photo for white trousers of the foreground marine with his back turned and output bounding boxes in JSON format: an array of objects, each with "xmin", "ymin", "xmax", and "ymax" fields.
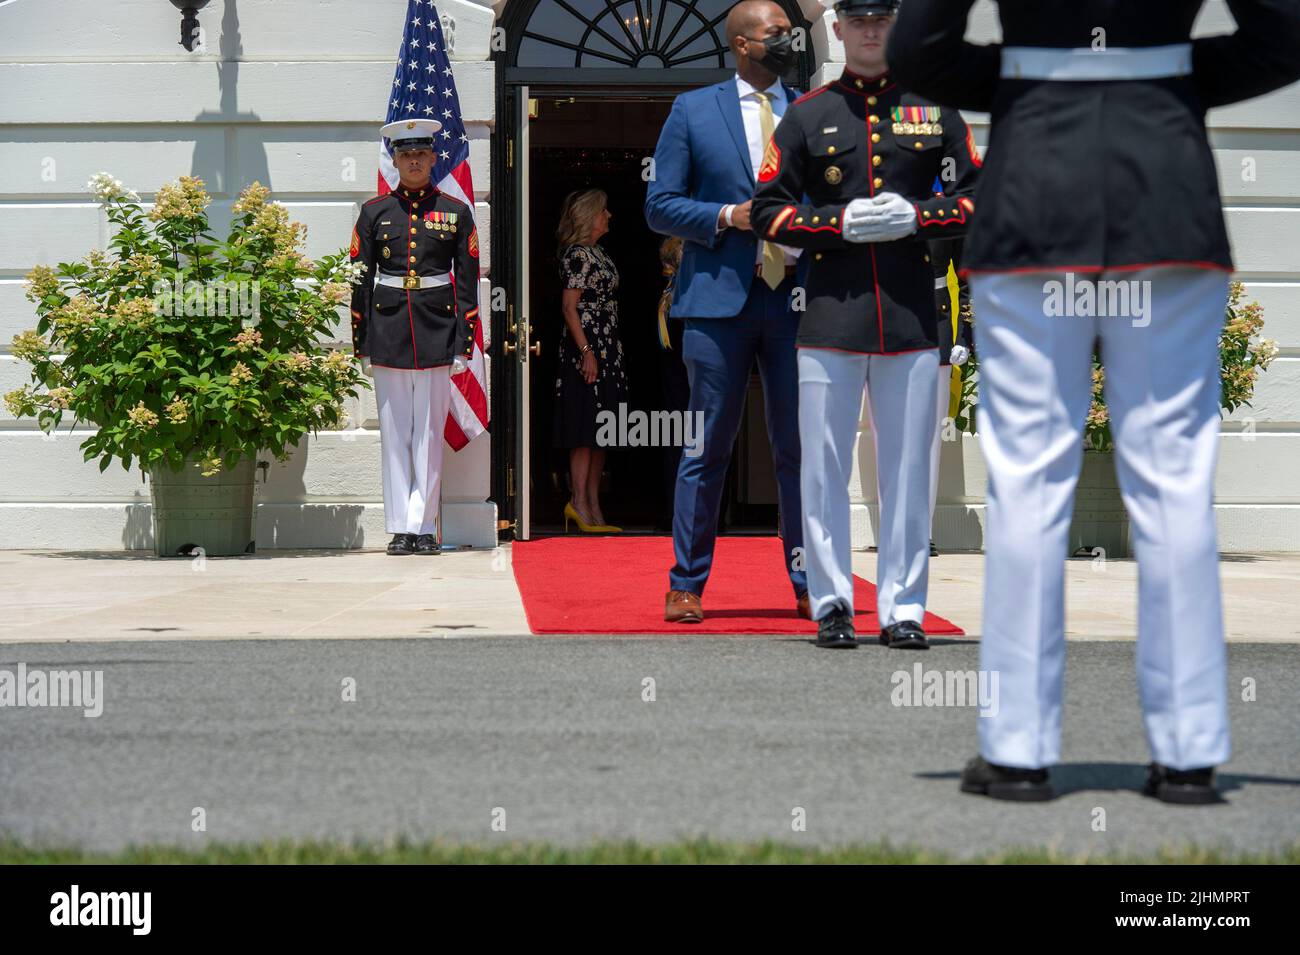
[{"xmin": 971, "ymin": 266, "xmax": 1230, "ymax": 769}]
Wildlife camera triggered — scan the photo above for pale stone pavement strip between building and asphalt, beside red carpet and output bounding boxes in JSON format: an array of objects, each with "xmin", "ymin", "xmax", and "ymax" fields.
[{"xmin": 0, "ymin": 544, "xmax": 1300, "ymax": 643}]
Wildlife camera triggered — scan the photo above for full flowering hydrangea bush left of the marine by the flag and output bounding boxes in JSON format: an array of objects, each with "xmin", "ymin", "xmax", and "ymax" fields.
[{"xmin": 4, "ymin": 173, "xmax": 369, "ymax": 476}]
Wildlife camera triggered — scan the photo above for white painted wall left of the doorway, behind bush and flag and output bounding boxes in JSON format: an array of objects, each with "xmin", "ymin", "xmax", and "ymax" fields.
[{"xmin": 0, "ymin": 0, "xmax": 497, "ymax": 548}]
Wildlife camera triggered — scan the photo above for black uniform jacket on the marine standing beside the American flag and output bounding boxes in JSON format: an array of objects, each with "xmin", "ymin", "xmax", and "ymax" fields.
[{"xmin": 351, "ymin": 186, "xmax": 478, "ymax": 369}]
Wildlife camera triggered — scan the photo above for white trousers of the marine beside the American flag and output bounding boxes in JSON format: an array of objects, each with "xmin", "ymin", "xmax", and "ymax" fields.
[{"xmin": 371, "ymin": 365, "xmax": 451, "ymax": 534}]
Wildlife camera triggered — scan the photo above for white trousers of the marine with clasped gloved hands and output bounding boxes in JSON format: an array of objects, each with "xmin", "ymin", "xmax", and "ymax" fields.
[{"xmin": 800, "ymin": 348, "xmax": 939, "ymax": 628}]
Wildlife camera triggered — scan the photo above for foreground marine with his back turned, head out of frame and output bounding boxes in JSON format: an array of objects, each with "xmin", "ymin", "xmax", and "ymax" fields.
[{"xmin": 889, "ymin": 0, "xmax": 1300, "ymax": 803}]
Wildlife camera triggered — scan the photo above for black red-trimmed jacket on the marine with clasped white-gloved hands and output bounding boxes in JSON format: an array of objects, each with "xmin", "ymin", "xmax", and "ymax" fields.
[{"xmin": 750, "ymin": 69, "xmax": 979, "ymax": 355}]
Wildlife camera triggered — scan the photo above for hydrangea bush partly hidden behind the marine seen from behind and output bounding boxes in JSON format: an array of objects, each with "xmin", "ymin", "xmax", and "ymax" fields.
[{"xmin": 957, "ymin": 282, "xmax": 1278, "ymax": 451}]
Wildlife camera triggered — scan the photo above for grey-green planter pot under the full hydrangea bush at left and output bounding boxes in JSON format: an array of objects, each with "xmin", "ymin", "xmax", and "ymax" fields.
[{"xmin": 150, "ymin": 457, "xmax": 256, "ymax": 557}]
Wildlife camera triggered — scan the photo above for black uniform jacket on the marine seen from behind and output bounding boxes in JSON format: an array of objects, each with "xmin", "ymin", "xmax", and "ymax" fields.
[{"xmin": 888, "ymin": 0, "xmax": 1300, "ymax": 272}]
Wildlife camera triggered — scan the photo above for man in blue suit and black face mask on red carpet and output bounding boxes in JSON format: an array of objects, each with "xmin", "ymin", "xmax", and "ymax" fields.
[{"xmin": 645, "ymin": 0, "xmax": 811, "ymax": 624}]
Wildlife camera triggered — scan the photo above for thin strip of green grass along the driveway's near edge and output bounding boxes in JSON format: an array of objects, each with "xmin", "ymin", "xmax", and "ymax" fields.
[{"xmin": 0, "ymin": 839, "xmax": 1300, "ymax": 865}]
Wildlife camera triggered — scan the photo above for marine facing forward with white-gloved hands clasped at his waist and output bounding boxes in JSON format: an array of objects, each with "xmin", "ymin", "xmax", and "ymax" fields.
[{"xmin": 751, "ymin": 0, "xmax": 979, "ymax": 648}]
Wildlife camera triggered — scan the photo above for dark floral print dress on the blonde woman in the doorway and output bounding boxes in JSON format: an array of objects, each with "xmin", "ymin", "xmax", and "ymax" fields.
[{"xmin": 555, "ymin": 244, "xmax": 628, "ymax": 448}]
